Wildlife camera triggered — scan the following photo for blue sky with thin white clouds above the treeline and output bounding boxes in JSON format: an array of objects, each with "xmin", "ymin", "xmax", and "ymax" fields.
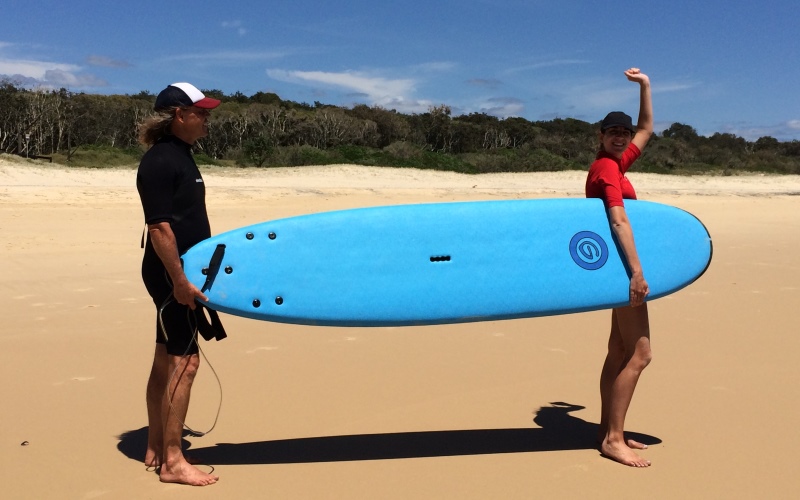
[{"xmin": 0, "ymin": 0, "xmax": 800, "ymax": 140}]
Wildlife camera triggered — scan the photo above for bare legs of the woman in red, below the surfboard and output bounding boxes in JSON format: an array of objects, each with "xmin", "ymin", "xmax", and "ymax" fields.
[{"xmin": 600, "ymin": 304, "xmax": 652, "ymax": 467}]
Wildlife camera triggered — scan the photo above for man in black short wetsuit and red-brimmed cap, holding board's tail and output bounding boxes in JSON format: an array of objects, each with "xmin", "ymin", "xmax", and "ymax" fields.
[{"xmin": 136, "ymin": 83, "xmax": 220, "ymax": 486}]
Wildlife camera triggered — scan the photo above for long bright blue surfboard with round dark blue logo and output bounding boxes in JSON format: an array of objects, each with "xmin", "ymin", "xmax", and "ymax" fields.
[{"xmin": 182, "ymin": 199, "xmax": 712, "ymax": 326}]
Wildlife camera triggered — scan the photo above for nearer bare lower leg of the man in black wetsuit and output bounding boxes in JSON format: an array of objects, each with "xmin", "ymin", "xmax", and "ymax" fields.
[{"xmin": 160, "ymin": 354, "xmax": 219, "ymax": 486}]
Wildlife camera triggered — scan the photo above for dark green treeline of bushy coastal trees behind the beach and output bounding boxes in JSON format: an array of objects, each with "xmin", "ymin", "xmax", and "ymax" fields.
[{"xmin": 0, "ymin": 81, "xmax": 800, "ymax": 174}]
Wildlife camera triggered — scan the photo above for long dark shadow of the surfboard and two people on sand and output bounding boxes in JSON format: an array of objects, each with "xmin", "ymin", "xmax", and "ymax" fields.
[{"xmin": 117, "ymin": 402, "xmax": 661, "ymax": 465}]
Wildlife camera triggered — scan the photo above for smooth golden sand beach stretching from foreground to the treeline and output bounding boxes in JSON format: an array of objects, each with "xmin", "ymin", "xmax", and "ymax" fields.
[{"xmin": 0, "ymin": 156, "xmax": 800, "ymax": 499}]
